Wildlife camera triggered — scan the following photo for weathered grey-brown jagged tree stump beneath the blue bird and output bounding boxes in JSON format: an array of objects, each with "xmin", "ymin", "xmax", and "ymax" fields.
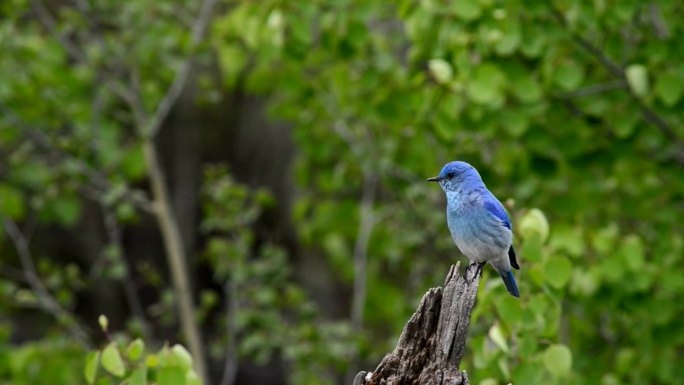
[{"xmin": 353, "ymin": 264, "xmax": 480, "ymax": 385}]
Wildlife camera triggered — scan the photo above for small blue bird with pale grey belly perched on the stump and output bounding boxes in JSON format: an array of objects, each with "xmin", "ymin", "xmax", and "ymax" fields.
[{"xmin": 428, "ymin": 161, "xmax": 520, "ymax": 297}]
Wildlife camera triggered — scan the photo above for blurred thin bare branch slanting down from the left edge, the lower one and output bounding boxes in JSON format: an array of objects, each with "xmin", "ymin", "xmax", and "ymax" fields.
[{"xmin": 3, "ymin": 217, "xmax": 92, "ymax": 348}]
